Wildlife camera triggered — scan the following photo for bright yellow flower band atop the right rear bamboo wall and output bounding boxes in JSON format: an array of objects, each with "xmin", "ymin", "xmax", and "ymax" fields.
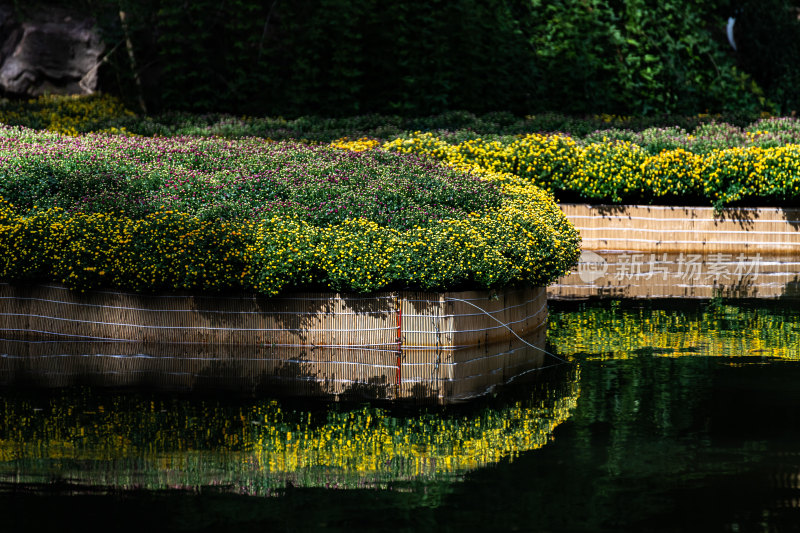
[{"xmin": 384, "ymin": 132, "xmax": 800, "ymax": 207}]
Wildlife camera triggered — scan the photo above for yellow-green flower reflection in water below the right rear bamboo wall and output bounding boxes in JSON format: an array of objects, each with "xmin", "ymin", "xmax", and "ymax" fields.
[{"xmin": 547, "ymin": 300, "xmax": 800, "ymax": 360}]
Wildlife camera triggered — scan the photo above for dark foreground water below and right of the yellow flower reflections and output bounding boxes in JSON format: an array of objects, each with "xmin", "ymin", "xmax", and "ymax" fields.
[{"xmin": 14, "ymin": 352, "xmax": 800, "ymax": 533}]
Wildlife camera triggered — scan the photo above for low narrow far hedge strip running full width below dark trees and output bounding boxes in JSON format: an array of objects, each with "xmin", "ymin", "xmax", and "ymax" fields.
[{"xmin": 0, "ymin": 94, "xmax": 800, "ymax": 141}]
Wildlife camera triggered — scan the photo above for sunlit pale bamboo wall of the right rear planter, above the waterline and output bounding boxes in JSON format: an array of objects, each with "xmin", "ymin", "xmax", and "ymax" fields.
[{"xmin": 561, "ymin": 204, "xmax": 800, "ymax": 255}]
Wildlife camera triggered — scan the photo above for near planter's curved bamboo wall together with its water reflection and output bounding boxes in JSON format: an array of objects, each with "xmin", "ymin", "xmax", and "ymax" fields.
[{"xmin": 0, "ymin": 285, "xmax": 547, "ymax": 402}]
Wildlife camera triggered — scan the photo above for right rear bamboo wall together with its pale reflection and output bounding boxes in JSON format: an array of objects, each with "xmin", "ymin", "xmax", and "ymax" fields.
[{"xmin": 548, "ymin": 204, "xmax": 800, "ymax": 298}]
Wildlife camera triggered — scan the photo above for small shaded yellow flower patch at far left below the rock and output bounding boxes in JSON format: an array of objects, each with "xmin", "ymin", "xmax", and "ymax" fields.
[{"xmin": 0, "ymin": 95, "xmax": 135, "ymax": 136}]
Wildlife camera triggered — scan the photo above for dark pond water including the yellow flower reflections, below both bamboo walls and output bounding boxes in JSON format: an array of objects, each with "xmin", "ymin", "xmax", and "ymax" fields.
[{"xmin": 0, "ymin": 300, "xmax": 800, "ymax": 532}]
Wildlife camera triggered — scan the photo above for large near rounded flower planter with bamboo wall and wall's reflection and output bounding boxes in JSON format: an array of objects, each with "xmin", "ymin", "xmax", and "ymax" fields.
[{"xmin": 0, "ymin": 128, "xmax": 579, "ymax": 402}]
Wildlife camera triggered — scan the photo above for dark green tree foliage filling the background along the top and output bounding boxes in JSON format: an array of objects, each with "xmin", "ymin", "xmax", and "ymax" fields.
[{"xmin": 9, "ymin": 0, "xmax": 800, "ymax": 117}]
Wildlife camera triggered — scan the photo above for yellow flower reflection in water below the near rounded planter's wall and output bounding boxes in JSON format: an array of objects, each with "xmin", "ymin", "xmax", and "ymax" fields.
[{"xmin": 0, "ymin": 370, "xmax": 580, "ymax": 493}]
